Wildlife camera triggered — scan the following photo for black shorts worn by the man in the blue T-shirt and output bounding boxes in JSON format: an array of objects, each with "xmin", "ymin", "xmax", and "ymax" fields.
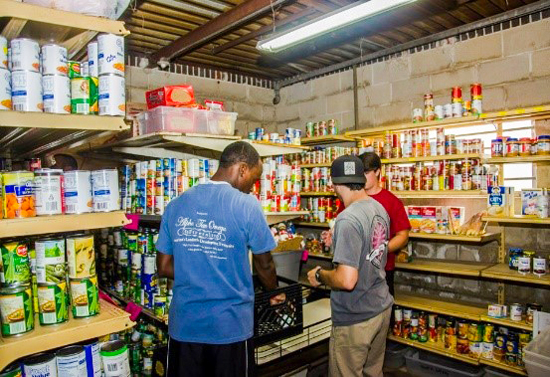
[{"xmin": 166, "ymin": 338, "xmax": 255, "ymax": 377}]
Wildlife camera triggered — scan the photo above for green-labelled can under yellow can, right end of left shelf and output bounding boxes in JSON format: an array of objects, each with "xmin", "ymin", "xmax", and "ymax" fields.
[{"xmin": 70, "ymin": 276, "xmax": 99, "ymax": 318}]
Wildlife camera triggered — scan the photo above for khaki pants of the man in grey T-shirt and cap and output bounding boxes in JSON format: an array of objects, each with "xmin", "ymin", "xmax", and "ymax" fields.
[{"xmin": 329, "ymin": 306, "xmax": 392, "ymax": 377}]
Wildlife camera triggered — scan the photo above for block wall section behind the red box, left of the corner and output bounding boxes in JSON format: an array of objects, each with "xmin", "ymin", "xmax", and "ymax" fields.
[{"xmin": 126, "ymin": 67, "xmax": 276, "ymax": 135}]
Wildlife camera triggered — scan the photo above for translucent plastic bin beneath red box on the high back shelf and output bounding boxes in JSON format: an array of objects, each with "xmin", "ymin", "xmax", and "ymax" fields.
[{"xmin": 143, "ymin": 106, "xmax": 237, "ymax": 135}]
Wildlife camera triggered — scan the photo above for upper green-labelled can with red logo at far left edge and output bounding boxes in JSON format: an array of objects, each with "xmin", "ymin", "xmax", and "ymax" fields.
[{"xmin": 0, "ymin": 241, "xmax": 31, "ymax": 287}]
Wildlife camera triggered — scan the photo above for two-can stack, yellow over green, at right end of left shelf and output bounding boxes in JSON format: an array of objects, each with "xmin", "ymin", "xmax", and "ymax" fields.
[{"xmin": 66, "ymin": 233, "xmax": 99, "ymax": 318}]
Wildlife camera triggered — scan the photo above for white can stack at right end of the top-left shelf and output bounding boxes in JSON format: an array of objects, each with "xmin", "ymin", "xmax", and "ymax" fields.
[{"xmin": 98, "ymin": 34, "xmax": 126, "ymax": 116}]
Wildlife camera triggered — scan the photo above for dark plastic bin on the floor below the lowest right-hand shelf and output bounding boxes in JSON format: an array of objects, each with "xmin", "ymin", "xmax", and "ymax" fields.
[{"xmin": 405, "ymin": 352, "xmax": 485, "ymax": 377}]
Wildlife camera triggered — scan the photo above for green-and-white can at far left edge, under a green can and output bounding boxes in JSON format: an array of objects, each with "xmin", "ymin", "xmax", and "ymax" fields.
[{"xmin": 0, "ymin": 285, "xmax": 34, "ymax": 336}]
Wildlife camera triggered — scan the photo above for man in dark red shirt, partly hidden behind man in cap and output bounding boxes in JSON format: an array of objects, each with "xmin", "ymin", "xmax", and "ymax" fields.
[{"xmin": 323, "ymin": 152, "xmax": 411, "ymax": 296}]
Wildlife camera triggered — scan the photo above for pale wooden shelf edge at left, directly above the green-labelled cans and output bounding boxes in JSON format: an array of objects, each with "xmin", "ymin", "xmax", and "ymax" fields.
[{"xmin": 0, "ymin": 211, "xmax": 130, "ymax": 238}]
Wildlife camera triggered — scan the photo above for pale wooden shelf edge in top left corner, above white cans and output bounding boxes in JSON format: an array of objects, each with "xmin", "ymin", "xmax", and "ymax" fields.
[{"xmin": 0, "ymin": 0, "xmax": 130, "ymax": 36}]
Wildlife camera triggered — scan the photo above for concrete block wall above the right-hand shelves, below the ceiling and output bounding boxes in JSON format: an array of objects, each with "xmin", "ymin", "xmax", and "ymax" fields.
[{"xmin": 276, "ymin": 19, "xmax": 550, "ymax": 134}]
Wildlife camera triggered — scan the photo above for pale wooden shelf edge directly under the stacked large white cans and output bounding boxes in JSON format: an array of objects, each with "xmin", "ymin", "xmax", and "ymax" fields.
[{"xmin": 0, "ymin": 110, "xmax": 130, "ymax": 131}]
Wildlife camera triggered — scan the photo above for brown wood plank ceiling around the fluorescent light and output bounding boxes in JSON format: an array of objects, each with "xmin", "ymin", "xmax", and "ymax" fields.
[{"xmin": 123, "ymin": 0, "xmax": 536, "ymax": 79}]
